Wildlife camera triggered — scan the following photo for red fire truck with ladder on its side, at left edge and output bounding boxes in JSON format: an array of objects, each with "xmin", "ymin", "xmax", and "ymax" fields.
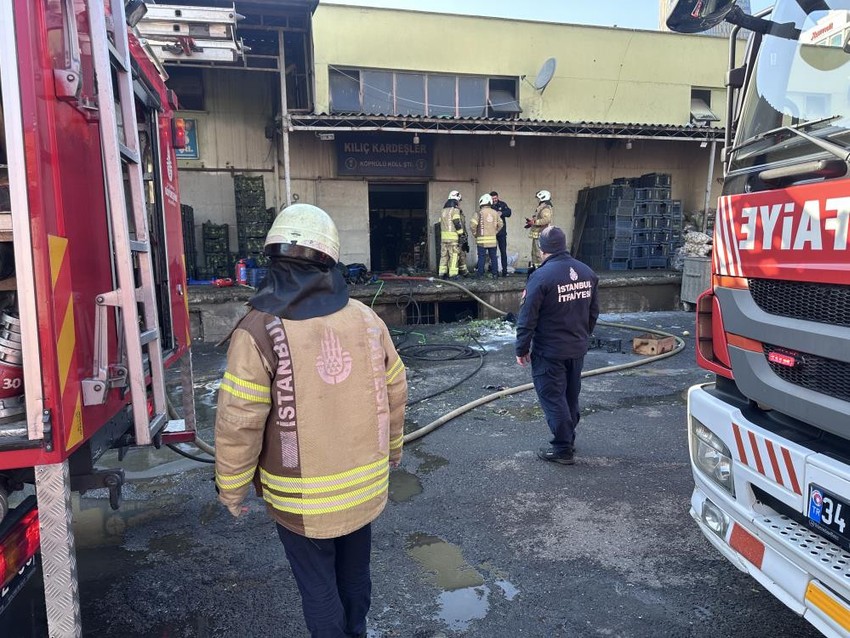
[{"xmin": 0, "ymin": 0, "xmax": 194, "ymax": 636}]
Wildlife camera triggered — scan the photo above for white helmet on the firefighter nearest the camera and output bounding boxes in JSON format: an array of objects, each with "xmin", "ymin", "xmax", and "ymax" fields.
[{"xmin": 264, "ymin": 204, "xmax": 339, "ymax": 266}]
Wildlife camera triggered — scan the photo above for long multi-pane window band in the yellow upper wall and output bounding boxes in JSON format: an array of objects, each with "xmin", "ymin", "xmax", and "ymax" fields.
[{"xmin": 329, "ymin": 67, "xmax": 522, "ymax": 118}]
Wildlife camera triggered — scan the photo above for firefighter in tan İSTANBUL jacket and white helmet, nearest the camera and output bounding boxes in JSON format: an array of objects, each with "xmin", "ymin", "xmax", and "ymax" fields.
[{"xmin": 215, "ymin": 204, "xmax": 407, "ymax": 638}]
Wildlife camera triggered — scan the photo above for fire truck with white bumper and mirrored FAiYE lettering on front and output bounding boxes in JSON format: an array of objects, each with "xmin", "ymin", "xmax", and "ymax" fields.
[{"xmin": 667, "ymin": 0, "xmax": 850, "ymax": 637}]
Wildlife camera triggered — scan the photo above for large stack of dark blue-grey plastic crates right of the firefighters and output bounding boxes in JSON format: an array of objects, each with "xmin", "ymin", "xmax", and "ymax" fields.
[{"xmin": 576, "ymin": 173, "xmax": 682, "ymax": 270}]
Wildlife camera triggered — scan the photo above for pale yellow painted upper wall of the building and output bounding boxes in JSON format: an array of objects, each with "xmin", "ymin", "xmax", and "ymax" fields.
[{"xmin": 313, "ymin": 4, "xmax": 728, "ymax": 126}]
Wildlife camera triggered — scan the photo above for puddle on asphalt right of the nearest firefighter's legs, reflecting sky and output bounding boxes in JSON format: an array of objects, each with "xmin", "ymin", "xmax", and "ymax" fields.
[{"xmin": 407, "ymin": 534, "xmax": 490, "ymax": 631}]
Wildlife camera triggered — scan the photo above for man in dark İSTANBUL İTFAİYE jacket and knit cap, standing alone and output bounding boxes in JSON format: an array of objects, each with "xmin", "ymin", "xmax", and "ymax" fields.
[{"xmin": 516, "ymin": 226, "xmax": 599, "ymax": 465}]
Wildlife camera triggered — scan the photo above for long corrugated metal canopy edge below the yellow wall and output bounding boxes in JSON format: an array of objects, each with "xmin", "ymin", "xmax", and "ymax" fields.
[{"xmin": 289, "ymin": 113, "xmax": 725, "ymax": 143}]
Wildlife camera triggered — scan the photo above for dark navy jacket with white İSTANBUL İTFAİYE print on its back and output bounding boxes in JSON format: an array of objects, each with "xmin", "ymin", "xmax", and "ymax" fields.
[{"xmin": 516, "ymin": 251, "xmax": 599, "ymax": 359}]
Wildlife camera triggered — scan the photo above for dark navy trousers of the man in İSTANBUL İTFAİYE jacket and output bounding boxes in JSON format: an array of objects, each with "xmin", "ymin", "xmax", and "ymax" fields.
[{"xmin": 531, "ymin": 351, "xmax": 584, "ymax": 452}]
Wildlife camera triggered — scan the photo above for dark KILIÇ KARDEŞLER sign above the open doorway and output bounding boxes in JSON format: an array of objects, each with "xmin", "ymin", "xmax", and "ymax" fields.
[{"xmin": 336, "ymin": 133, "xmax": 434, "ymax": 177}]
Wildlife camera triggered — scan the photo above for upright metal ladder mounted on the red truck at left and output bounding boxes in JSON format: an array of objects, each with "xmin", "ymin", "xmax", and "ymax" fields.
[{"xmin": 83, "ymin": 0, "xmax": 168, "ymax": 445}]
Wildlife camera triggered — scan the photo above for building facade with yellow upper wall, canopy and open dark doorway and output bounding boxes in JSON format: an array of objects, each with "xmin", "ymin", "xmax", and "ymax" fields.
[{"xmin": 168, "ymin": 2, "xmax": 728, "ymax": 271}]
